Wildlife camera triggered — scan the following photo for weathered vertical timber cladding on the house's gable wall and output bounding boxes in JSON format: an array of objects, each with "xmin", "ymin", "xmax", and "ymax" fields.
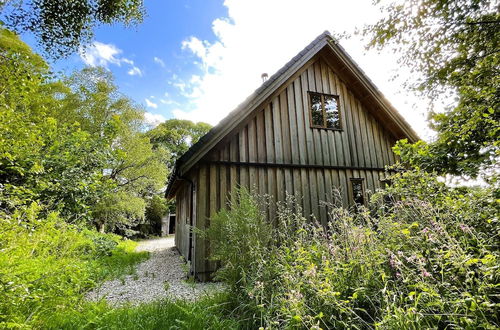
[{"xmin": 196, "ymin": 57, "xmax": 395, "ymax": 271}]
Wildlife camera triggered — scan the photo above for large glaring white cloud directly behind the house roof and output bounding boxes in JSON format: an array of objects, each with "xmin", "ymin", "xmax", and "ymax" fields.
[{"xmin": 174, "ymin": 0, "xmax": 432, "ymax": 139}]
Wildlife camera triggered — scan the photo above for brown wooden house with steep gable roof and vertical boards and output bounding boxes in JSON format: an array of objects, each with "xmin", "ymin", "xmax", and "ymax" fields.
[{"xmin": 166, "ymin": 32, "xmax": 418, "ymax": 280}]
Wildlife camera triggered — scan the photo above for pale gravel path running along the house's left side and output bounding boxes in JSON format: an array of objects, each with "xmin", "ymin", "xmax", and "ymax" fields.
[{"xmin": 87, "ymin": 237, "xmax": 221, "ymax": 305}]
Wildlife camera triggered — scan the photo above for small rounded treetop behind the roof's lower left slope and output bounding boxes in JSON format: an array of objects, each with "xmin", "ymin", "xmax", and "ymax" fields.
[{"xmin": 148, "ymin": 119, "xmax": 212, "ymax": 168}]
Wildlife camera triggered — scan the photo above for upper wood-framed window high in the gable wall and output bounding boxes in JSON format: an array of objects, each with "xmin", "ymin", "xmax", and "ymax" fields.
[{"xmin": 309, "ymin": 92, "xmax": 342, "ymax": 129}]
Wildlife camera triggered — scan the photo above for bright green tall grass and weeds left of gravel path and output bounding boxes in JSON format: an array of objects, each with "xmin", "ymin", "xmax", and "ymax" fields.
[{"xmin": 0, "ymin": 203, "xmax": 147, "ymax": 328}]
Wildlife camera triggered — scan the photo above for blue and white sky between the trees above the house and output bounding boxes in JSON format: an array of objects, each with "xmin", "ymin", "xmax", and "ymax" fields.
[{"xmin": 26, "ymin": 0, "xmax": 438, "ymax": 139}]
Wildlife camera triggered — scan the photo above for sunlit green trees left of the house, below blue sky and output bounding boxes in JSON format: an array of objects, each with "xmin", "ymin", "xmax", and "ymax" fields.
[{"xmin": 0, "ymin": 30, "xmax": 168, "ymax": 235}]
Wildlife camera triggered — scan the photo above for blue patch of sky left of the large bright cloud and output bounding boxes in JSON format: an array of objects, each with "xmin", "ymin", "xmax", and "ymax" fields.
[{"xmin": 32, "ymin": 0, "xmax": 227, "ymax": 125}]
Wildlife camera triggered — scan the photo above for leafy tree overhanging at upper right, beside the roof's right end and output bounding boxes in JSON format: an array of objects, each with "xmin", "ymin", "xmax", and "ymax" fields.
[{"xmin": 364, "ymin": 0, "xmax": 500, "ymax": 176}]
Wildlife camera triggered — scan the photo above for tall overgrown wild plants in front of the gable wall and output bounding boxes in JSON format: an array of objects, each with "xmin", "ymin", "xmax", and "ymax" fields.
[{"xmin": 208, "ymin": 184, "xmax": 500, "ymax": 329}]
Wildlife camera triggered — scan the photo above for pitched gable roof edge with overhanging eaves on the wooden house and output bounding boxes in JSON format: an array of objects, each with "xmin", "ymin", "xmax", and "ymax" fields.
[{"xmin": 165, "ymin": 31, "xmax": 420, "ymax": 197}]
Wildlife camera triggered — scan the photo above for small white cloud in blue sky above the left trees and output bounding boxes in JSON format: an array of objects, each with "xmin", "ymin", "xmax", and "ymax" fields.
[{"xmin": 80, "ymin": 41, "xmax": 142, "ymax": 76}]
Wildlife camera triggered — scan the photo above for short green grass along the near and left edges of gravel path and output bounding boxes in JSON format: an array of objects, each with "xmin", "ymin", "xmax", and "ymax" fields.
[{"xmin": 20, "ymin": 233, "xmax": 241, "ymax": 330}]
